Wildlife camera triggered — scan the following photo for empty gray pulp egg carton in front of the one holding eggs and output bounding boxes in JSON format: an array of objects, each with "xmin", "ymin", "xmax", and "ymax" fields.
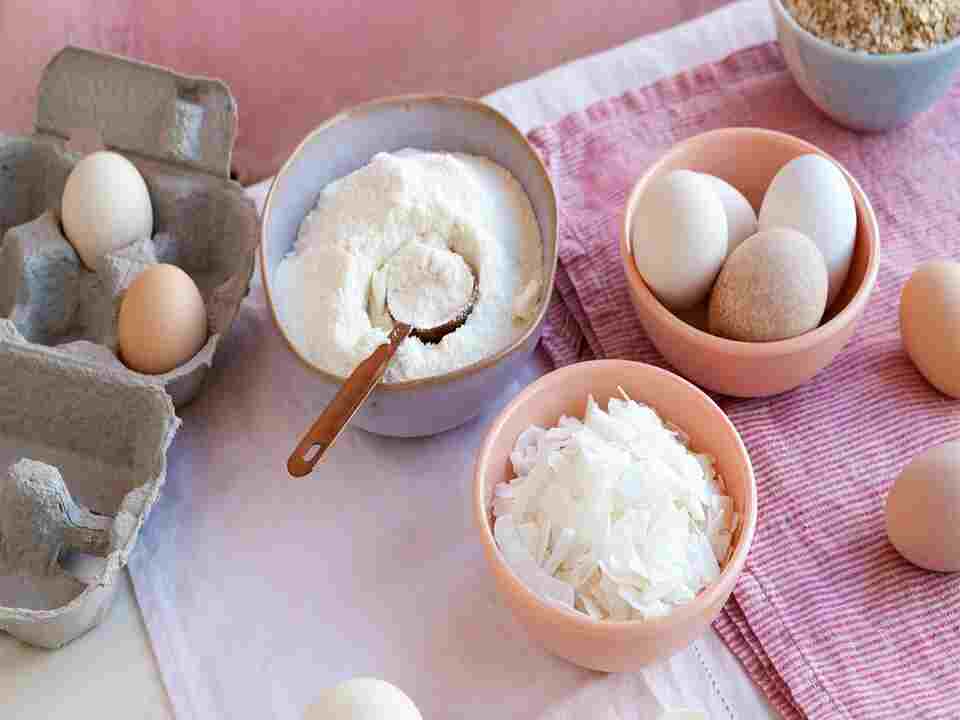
[{"xmin": 0, "ymin": 320, "xmax": 180, "ymax": 648}]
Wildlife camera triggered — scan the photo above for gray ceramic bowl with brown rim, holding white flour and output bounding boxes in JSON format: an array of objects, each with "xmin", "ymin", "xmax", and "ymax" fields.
[{"xmin": 260, "ymin": 95, "xmax": 557, "ymax": 437}]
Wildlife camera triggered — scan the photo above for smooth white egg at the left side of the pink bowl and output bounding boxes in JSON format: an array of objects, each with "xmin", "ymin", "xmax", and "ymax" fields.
[{"xmin": 630, "ymin": 170, "xmax": 727, "ymax": 310}]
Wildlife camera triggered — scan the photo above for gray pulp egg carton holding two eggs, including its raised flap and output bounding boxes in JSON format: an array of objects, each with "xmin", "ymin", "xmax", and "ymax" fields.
[{"xmin": 0, "ymin": 47, "xmax": 258, "ymax": 406}]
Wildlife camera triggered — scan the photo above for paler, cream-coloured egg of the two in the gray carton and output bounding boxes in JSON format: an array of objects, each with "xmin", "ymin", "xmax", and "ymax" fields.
[{"xmin": 60, "ymin": 151, "xmax": 153, "ymax": 270}]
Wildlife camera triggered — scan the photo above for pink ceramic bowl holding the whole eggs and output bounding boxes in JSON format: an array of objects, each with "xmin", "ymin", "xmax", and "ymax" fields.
[{"xmin": 620, "ymin": 128, "xmax": 880, "ymax": 397}]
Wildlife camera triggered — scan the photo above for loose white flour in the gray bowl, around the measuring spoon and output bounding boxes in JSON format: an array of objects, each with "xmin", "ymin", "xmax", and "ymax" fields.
[{"xmin": 275, "ymin": 150, "xmax": 543, "ymax": 382}]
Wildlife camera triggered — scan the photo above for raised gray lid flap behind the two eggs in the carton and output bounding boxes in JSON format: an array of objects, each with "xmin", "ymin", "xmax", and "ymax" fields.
[{"xmin": 35, "ymin": 46, "xmax": 237, "ymax": 178}]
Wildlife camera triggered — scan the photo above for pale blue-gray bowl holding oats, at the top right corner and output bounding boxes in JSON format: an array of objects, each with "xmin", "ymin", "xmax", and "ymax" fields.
[{"xmin": 770, "ymin": 0, "xmax": 960, "ymax": 131}]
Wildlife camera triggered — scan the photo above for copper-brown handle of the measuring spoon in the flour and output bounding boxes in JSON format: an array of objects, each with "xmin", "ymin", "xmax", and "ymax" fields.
[{"xmin": 287, "ymin": 323, "xmax": 413, "ymax": 477}]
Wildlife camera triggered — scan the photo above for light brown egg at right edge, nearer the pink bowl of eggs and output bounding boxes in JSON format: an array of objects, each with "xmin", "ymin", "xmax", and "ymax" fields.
[{"xmin": 900, "ymin": 260, "xmax": 960, "ymax": 398}]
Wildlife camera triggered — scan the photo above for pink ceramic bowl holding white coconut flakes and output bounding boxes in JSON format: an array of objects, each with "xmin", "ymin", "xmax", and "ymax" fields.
[{"xmin": 473, "ymin": 360, "xmax": 757, "ymax": 672}]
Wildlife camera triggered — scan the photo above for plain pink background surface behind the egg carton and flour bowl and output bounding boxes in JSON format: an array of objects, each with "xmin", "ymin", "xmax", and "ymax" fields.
[{"xmin": 0, "ymin": 0, "xmax": 726, "ymax": 182}]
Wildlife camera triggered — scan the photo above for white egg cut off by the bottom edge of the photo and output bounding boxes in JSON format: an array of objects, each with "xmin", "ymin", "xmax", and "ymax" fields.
[{"xmin": 303, "ymin": 678, "xmax": 423, "ymax": 720}]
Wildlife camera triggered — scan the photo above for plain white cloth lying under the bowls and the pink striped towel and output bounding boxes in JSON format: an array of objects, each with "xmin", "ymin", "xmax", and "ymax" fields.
[{"xmin": 131, "ymin": 0, "xmax": 774, "ymax": 720}]
